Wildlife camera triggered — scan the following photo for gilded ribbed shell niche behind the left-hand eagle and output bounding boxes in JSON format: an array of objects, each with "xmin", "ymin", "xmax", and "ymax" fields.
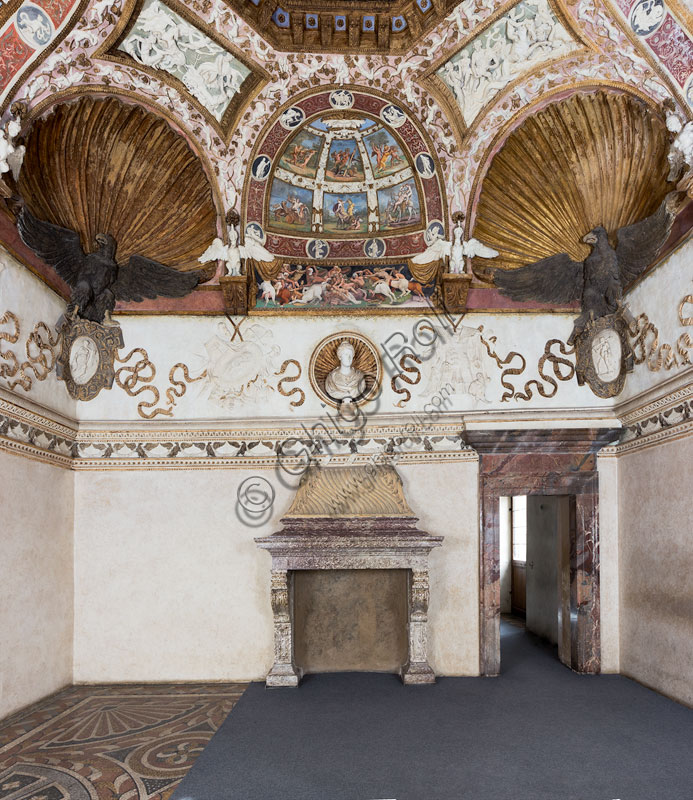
[{"xmin": 19, "ymin": 97, "xmax": 216, "ymax": 270}]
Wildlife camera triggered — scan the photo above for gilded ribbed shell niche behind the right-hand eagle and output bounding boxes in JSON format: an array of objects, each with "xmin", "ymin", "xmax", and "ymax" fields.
[{"xmin": 473, "ymin": 90, "xmax": 672, "ymax": 288}]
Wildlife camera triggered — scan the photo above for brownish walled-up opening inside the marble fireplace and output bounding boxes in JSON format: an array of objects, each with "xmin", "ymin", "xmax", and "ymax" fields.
[{"xmin": 291, "ymin": 569, "xmax": 409, "ymax": 673}]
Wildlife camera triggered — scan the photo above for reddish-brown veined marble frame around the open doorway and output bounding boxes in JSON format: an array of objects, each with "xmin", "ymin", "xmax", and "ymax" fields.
[{"xmin": 466, "ymin": 428, "xmax": 618, "ymax": 676}]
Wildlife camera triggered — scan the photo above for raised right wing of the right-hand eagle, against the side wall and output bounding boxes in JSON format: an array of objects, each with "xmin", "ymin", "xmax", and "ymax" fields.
[{"xmin": 616, "ymin": 192, "xmax": 679, "ymax": 287}]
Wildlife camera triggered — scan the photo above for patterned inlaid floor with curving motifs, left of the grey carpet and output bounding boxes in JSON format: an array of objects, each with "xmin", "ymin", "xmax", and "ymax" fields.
[{"xmin": 0, "ymin": 683, "xmax": 246, "ymax": 800}]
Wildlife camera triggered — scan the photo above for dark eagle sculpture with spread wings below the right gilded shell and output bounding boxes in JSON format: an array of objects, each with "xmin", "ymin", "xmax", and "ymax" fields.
[{"xmin": 488, "ymin": 192, "xmax": 681, "ymax": 344}]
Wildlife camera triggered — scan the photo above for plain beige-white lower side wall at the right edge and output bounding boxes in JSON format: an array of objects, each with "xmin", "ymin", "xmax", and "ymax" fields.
[{"xmin": 618, "ymin": 436, "xmax": 693, "ymax": 705}]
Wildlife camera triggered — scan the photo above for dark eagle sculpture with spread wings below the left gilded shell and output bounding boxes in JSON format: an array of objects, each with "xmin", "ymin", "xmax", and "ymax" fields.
[{"xmin": 17, "ymin": 205, "xmax": 203, "ymax": 325}]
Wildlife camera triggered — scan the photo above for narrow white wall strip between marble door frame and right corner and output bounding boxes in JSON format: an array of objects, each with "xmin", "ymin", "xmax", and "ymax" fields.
[{"xmin": 597, "ymin": 451, "xmax": 620, "ymax": 673}]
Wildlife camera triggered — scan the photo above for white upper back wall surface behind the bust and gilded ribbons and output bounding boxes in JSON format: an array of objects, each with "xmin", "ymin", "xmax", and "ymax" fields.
[{"xmin": 77, "ymin": 313, "xmax": 612, "ymax": 421}]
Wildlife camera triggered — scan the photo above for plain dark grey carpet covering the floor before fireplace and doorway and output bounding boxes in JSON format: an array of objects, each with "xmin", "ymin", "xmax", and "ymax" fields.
[{"xmin": 171, "ymin": 623, "xmax": 693, "ymax": 800}]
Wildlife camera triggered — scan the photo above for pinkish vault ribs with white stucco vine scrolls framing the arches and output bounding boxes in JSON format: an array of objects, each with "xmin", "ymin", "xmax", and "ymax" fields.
[{"xmin": 2, "ymin": 0, "xmax": 688, "ymax": 228}]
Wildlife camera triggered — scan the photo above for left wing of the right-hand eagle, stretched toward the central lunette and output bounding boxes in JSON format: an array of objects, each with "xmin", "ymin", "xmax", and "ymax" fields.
[{"xmin": 492, "ymin": 253, "xmax": 583, "ymax": 303}]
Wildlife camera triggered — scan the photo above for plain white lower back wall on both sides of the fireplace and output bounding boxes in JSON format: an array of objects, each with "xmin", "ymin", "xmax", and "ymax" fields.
[{"xmin": 74, "ymin": 463, "xmax": 479, "ymax": 682}]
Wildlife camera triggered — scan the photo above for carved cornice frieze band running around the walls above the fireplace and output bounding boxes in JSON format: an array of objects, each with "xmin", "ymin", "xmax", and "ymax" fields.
[{"xmin": 0, "ymin": 381, "xmax": 693, "ymax": 466}]
